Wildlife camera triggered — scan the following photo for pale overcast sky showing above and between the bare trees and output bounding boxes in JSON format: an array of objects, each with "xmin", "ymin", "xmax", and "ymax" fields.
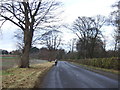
[{"xmin": 0, "ymin": 0, "xmax": 117, "ymax": 51}]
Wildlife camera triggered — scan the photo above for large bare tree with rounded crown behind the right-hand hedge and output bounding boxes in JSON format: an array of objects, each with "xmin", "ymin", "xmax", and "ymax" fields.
[{"xmin": 72, "ymin": 15, "xmax": 106, "ymax": 58}]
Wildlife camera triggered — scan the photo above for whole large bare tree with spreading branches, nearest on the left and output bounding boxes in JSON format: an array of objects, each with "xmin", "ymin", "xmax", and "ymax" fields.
[{"xmin": 0, "ymin": 0, "xmax": 60, "ymax": 68}]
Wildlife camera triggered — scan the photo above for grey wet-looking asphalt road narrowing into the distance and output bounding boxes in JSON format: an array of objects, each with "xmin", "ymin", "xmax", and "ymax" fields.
[{"xmin": 42, "ymin": 61, "xmax": 118, "ymax": 88}]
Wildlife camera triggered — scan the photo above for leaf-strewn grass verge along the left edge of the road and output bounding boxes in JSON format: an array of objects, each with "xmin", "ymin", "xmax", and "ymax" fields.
[{"xmin": 2, "ymin": 62, "xmax": 53, "ymax": 88}]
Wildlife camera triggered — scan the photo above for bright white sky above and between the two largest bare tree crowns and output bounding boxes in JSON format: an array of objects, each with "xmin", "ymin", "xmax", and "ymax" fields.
[{"xmin": 62, "ymin": 0, "xmax": 115, "ymax": 23}]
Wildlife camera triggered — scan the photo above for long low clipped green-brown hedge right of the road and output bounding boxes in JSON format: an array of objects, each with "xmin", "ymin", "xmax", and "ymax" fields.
[{"xmin": 77, "ymin": 57, "xmax": 120, "ymax": 70}]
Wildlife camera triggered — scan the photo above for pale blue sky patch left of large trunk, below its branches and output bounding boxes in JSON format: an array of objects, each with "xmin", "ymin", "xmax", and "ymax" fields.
[{"xmin": 0, "ymin": 22, "xmax": 17, "ymax": 51}]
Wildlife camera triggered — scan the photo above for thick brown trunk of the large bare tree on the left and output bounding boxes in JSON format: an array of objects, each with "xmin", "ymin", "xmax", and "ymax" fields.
[{"xmin": 20, "ymin": 2, "xmax": 33, "ymax": 68}]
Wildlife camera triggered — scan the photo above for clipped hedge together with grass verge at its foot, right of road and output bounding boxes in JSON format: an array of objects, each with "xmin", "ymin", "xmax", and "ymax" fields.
[{"xmin": 68, "ymin": 57, "xmax": 120, "ymax": 74}]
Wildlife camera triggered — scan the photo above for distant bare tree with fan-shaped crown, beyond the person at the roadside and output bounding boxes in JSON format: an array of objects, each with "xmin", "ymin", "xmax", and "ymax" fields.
[{"xmin": 40, "ymin": 30, "xmax": 62, "ymax": 60}]
